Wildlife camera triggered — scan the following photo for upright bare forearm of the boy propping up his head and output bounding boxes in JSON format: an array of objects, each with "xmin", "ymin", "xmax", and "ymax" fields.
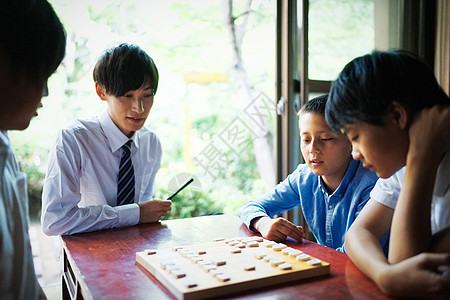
[{"xmin": 389, "ymin": 156, "xmax": 437, "ymax": 263}]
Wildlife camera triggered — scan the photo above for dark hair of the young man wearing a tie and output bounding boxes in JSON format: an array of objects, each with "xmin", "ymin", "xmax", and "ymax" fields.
[{"xmin": 93, "ymin": 43, "xmax": 159, "ymax": 97}]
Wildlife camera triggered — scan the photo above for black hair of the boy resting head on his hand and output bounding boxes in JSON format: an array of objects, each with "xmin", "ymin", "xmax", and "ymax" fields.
[{"xmin": 325, "ymin": 51, "xmax": 450, "ymax": 131}]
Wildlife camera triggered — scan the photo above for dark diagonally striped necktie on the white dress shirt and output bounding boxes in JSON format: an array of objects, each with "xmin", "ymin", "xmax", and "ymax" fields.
[{"xmin": 117, "ymin": 140, "xmax": 134, "ymax": 205}]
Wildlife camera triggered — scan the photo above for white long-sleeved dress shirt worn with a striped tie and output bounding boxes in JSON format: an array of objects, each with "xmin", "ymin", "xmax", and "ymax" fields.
[{"xmin": 41, "ymin": 111, "xmax": 162, "ymax": 235}]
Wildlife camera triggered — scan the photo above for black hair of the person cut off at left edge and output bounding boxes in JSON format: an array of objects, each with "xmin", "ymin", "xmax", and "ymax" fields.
[{"xmin": 0, "ymin": 0, "xmax": 66, "ymax": 85}]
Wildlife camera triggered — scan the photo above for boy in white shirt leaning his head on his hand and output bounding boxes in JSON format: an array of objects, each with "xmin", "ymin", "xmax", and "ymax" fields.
[{"xmin": 326, "ymin": 51, "xmax": 450, "ymax": 297}]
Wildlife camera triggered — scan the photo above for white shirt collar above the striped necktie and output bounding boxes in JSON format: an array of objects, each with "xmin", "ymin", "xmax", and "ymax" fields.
[{"xmin": 98, "ymin": 110, "xmax": 140, "ymax": 153}]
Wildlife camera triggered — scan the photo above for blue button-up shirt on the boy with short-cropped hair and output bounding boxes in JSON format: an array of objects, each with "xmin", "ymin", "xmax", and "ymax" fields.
[{"xmin": 239, "ymin": 158, "xmax": 378, "ymax": 251}]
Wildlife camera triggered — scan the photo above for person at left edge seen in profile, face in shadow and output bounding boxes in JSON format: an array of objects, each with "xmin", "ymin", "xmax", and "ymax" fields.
[{"xmin": 0, "ymin": 0, "xmax": 66, "ymax": 300}]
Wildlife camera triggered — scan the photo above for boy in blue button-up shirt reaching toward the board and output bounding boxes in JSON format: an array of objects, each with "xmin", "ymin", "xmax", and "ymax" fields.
[{"xmin": 239, "ymin": 95, "xmax": 378, "ymax": 251}]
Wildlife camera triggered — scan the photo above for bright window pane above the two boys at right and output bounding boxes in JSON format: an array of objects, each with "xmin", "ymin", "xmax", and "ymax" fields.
[{"xmin": 308, "ymin": 0, "xmax": 375, "ymax": 80}]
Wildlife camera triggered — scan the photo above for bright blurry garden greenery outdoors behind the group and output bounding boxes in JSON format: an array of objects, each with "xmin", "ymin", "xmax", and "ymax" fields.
[{"xmin": 10, "ymin": 0, "xmax": 373, "ymax": 218}]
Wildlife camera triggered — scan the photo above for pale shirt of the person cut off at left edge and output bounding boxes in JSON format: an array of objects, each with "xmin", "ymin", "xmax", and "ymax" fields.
[{"xmin": 0, "ymin": 131, "xmax": 41, "ymax": 299}]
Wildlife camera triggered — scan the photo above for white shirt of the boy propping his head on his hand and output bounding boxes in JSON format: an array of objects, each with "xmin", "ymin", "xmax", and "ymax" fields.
[{"xmin": 370, "ymin": 152, "xmax": 450, "ymax": 234}]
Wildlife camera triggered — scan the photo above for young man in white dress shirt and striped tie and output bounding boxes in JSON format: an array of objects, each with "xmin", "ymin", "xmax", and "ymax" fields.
[{"xmin": 41, "ymin": 44, "xmax": 171, "ymax": 235}]
